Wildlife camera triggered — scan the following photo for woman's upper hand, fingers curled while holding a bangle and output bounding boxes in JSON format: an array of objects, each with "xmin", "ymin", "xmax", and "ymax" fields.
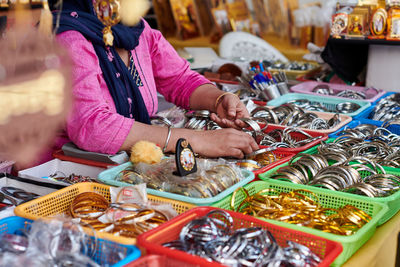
[{"xmin": 211, "ymin": 94, "xmax": 250, "ymax": 129}]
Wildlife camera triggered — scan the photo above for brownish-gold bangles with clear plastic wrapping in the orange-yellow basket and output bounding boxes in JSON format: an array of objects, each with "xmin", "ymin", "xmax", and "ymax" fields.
[{"xmin": 69, "ymin": 192, "xmax": 168, "ymax": 238}]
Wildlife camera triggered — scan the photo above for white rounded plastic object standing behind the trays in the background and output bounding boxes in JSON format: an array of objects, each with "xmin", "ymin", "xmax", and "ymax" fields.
[{"xmin": 219, "ymin": 32, "xmax": 289, "ymax": 62}]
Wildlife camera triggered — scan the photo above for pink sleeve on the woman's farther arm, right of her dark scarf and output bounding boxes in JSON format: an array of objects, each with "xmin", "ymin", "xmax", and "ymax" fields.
[{"xmin": 146, "ymin": 27, "xmax": 210, "ymax": 109}]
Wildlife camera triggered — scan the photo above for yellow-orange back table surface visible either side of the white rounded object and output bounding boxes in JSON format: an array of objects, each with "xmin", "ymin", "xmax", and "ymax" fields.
[{"xmin": 167, "ymin": 35, "xmax": 308, "ymax": 60}]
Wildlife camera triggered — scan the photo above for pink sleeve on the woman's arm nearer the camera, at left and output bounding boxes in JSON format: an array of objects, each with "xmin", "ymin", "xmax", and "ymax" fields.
[{"xmin": 57, "ymin": 31, "xmax": 134, "ymax": 154}]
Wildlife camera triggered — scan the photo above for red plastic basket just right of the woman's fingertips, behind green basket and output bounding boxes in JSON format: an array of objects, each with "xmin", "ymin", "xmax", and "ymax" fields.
[{"xmin": 260, "ymin": 124, "xmax": 328, "ymax": 154}]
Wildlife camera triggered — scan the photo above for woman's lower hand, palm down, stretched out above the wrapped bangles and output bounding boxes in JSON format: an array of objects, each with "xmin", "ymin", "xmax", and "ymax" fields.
[{"xmin": 191, "ymin": 128, "xmax": 259, "ymax": 158}]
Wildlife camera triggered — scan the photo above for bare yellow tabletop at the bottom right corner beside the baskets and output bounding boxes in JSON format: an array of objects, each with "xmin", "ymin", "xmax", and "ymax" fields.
[{"xmin": 343, "ymin": 212, "xmax": 400, "ymax": 267}]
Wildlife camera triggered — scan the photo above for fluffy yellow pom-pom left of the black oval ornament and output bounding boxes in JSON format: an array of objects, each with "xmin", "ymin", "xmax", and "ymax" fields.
[{"xmin": 131, "ymin": 141, "xmax": 164, "ymax": 164}]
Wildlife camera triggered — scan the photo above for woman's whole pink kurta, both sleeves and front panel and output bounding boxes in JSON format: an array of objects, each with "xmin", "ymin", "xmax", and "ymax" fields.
[{"xmin": 57, "ymin": 22, "xmax": 210, "ymax": 154}]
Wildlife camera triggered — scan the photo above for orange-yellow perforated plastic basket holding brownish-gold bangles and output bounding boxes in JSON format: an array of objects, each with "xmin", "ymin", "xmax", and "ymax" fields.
[{"xmin": 14, "ymin": 183, "xmax": 194, "ymax": 245}]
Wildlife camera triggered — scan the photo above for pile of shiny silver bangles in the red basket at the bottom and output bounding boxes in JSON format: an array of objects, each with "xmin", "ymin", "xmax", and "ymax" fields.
[{"xmin": 163, "ymin": 210, "xmax": 321, "ymax": 266}]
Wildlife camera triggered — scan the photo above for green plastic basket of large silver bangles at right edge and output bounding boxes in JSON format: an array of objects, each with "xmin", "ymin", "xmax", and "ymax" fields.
[{"xmin": 258, "ymin": 139, "xmax": 400, "ymax": 225}]
